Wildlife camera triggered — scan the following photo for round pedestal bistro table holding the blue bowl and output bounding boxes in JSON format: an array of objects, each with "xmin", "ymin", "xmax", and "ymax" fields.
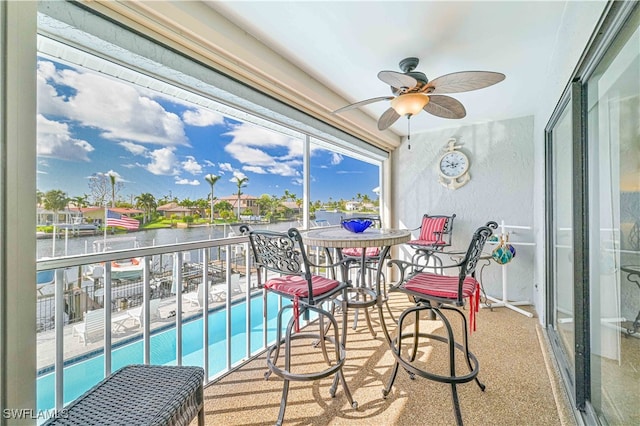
[{"xmin": 301, "ymin": 226, "xmax": 411, "ymax": 337}]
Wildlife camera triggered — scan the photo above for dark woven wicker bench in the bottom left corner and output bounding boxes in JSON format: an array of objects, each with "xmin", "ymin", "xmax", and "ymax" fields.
[{"xmin": 45, "ymin": 365, "xmax": 204, "ymax": 426}]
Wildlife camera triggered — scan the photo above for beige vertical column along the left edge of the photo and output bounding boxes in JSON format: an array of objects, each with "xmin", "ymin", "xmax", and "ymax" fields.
[{"xmin": 0, "ymin": 1, "xmax": 37, "ymax": 425}]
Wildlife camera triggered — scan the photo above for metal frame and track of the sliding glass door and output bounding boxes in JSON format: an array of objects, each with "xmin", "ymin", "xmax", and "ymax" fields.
[{"xmin": 545, "ymin": 1, "xmax": 640, "ymax": 424}]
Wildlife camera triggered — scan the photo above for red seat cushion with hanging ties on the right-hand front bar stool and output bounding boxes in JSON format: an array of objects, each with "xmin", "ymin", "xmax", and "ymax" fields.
[{"xmin": 404, "ymin": 272, "xmax": 480, "ymax": 331}]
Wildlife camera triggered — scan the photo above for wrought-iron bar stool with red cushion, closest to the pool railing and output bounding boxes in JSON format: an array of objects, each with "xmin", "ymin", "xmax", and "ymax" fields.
[{"xmin": 240, "ymin": 225, "xmax": 358, "ymax": 425}]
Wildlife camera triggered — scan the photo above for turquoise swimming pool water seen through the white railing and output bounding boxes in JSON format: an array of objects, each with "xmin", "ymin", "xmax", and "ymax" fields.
[{"xmin": 37, "ymin": 294, "xmax": 290, "ymax": 410}]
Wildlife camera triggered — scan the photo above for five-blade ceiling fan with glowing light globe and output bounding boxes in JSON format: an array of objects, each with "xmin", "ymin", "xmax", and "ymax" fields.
[{"xmin": 332, "ymin": 58, "xmax": 505, "ymax": 130}]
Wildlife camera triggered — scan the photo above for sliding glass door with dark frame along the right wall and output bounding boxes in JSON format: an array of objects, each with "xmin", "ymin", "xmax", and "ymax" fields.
[{"xmin": 546, "ymin": 2, "xmax": 640, "ymax": 425}]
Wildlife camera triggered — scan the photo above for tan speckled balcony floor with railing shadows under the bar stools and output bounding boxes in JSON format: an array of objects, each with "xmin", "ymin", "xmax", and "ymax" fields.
[{"xmin": 193, "ymin": 295, "xmax": 575, "ymax": 426}]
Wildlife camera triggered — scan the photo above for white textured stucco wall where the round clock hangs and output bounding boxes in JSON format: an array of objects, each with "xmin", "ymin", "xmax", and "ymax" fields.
[{"xmin": 391, "ymin": 116, "xmax": 535, "ymax": 301}]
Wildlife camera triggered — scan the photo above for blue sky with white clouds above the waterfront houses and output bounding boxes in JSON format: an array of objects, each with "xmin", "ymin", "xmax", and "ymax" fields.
[{"xmin": 37, "ymin": 57, "xmax": 378, "ymax": 205}]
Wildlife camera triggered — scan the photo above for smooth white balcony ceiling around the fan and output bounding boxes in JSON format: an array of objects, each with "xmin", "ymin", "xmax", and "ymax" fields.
[{"xmin": 207, "ymin": 1, "xmax": 570, "ymax": 135}]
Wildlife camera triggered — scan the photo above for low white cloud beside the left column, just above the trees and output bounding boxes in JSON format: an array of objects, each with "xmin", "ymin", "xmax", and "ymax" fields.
[{"xmin": 37, "ymin": 114, "xmax": 94, "ymax": 161}]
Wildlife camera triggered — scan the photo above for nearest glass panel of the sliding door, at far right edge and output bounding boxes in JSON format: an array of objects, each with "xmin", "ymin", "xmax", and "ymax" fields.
[{"xmin": 587, "ymin": 13, "xmax": 640, "ymax": 424}]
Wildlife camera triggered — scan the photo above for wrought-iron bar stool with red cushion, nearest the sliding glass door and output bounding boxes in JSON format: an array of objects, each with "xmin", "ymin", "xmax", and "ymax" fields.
[{"xmin": 383, "ymin": 222, "xmax": 498, "ymax": 425}]
